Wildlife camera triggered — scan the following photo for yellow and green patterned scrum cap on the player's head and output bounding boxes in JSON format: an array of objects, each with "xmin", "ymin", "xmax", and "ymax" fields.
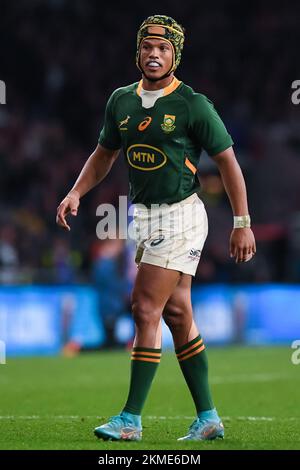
[{"xmin": 136, "ymin": 15, "xmax": 184, "ymax": 73}]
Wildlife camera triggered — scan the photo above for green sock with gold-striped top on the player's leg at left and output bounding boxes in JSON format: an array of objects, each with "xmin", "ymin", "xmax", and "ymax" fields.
[{"xmin": 123, "ymin": 347, "xmax": 161, "ymax": 415}]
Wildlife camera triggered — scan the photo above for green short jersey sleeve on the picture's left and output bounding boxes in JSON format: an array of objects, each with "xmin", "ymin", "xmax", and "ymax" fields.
[{"xmin": 98, "ymin": 93, "xmax": 121, "ymax": 150}]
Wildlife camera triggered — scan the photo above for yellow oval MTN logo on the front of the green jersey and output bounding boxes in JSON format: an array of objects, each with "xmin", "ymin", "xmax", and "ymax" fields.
[{"xmin": 126, "ymin": 144, "xmax": 168, "ymax": 171}]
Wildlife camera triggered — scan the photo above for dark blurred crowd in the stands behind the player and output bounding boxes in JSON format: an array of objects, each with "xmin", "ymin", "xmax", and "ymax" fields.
[{"xmin": 0, "ymin": 0, "xmax": 300, "ymax": 290}]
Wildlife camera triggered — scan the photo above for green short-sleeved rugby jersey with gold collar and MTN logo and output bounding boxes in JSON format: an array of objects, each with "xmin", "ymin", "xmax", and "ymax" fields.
[{"xmin": 99, "ymin": 77, "xmax": 233, "ymax": 207}]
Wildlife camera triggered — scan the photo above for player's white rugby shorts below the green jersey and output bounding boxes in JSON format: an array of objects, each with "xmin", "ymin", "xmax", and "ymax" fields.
[{"xmin": 133, "ymin": 193, "xmax": 208, "ymax": 276}]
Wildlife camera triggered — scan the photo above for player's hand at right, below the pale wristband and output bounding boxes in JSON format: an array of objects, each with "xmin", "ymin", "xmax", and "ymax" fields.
[{"xmin": 230, "ymin": 228, "xmax": 256, "ymax": 263}]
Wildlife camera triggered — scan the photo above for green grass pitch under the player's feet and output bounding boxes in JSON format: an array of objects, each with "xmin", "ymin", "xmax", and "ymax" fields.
[{"xmin": 0, "ymin": 346, "xmax": 300, "ymax": 450}]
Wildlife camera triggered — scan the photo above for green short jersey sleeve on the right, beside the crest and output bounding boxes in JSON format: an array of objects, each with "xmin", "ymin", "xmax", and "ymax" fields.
[{"xmin": 190, "ymin": 94, "xmax": 233, "ymax": 156}]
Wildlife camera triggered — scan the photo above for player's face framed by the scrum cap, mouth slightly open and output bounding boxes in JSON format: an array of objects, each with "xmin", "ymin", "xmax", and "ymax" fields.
[{"xmin": 140, "ymin": 39, "xmax": 173, "ymax": 80}]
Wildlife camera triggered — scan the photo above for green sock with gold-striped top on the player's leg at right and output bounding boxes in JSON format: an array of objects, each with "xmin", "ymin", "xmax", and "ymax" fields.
[{"xmin": 176, "ymin": 335, "xmax": 214, "ymax": 414}]
